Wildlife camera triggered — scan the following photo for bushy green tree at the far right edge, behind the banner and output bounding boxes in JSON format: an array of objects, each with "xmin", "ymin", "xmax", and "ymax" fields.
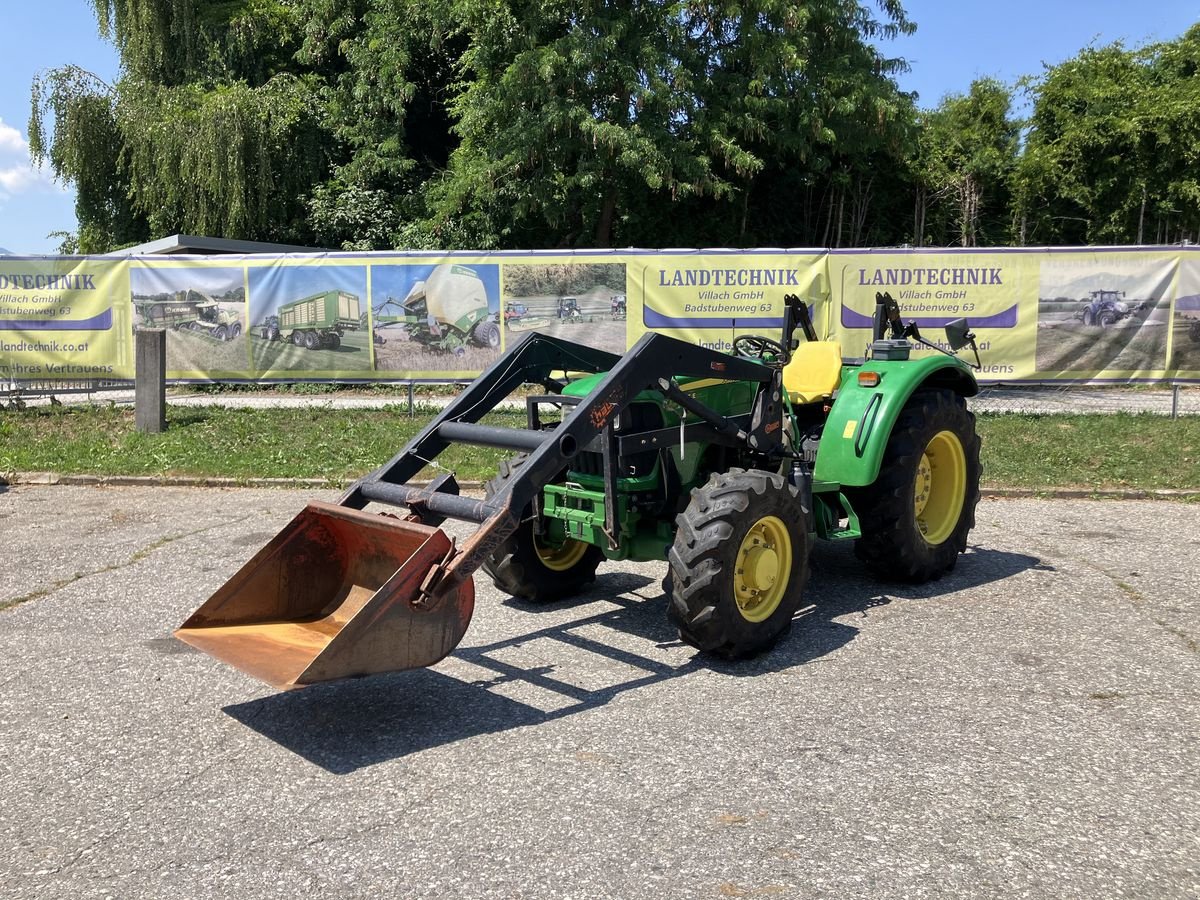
[{"xmin": 1018, "ymin": 26, "xmax": 1200, "ymax": 244}]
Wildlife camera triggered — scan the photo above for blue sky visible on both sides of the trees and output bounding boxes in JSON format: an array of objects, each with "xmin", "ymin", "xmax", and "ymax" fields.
[{"xmin": 0, "ymin": 0, "xmax": 1200, "ymax": 253}]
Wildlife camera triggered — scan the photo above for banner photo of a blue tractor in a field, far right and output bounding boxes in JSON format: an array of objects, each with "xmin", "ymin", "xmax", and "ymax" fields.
[{"xmin": 1037, "ymin": 252, "xmax": 1177, "ymax": 378}]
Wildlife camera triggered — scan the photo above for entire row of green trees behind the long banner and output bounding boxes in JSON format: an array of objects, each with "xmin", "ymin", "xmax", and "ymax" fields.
[{"xmin": 30, "ymin": 0, "xmax": 1200, "ymax": 252}]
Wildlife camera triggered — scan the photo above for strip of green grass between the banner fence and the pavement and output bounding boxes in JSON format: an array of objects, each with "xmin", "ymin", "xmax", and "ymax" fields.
[{"xmin": 0, "ymin": 407, "xmax": 1200, "ymax": 490}]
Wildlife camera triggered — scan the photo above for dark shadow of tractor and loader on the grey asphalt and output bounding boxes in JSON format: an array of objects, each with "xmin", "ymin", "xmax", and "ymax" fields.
[{"xmin": 223, "ymin": 545, "xmax": 1043, "ymax": 775}]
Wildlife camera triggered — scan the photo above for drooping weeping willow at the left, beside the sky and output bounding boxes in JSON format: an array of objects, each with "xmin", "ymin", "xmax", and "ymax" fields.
[{"xmin": 30, "ymin": 0, "xmax": 330, "ymax": 252}]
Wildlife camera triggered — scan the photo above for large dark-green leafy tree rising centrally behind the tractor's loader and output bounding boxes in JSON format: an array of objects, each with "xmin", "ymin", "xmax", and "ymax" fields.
[{"xmin": 431, "ymin": 0, "xmax": 911, "ymax": 246}]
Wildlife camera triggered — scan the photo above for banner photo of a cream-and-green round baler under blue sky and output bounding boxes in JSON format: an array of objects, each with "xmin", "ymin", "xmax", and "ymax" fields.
[{"xmin": 371, "ymin": 263, "xmax": 500, "ymax": 374}]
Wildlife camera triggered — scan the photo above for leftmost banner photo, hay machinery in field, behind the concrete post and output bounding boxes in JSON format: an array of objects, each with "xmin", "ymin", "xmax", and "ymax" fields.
[{"xmin": 130, "ymin": 265, "xmax": 247, "ymax": 378}]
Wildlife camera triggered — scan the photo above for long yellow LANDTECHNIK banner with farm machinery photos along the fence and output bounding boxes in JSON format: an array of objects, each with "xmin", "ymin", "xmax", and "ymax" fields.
[{"xmin": 0, "ymin": 247, "xmax": 1200, "ymax": 383}]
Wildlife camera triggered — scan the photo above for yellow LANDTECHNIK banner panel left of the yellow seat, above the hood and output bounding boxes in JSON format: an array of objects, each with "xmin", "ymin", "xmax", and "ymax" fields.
[{"xmin": 630, "ymin": 252, "xmax": 835, "ymax": 350}]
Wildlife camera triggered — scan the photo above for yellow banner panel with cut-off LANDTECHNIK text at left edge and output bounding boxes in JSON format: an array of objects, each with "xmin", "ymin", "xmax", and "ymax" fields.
[{"xmin": 0, "ymin": 258, "xmax": 133, "ymax": 380}]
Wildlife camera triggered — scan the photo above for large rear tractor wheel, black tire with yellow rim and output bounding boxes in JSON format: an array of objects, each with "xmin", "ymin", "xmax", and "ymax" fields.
[{"xmin": 846, "ymin": 390, "xmax": 980, "ymax": 583}]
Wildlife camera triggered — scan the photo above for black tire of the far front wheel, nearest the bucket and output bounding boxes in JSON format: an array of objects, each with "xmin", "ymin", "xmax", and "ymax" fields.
[{"xmin": 484, "ymin": 454, "xmax": 604, "ymax": 602}]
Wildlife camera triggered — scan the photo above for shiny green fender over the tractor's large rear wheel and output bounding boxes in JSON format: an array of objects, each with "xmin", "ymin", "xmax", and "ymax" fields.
[{"xmin": 812, "ymin": 354, "xmax": 979, "ymax": 487}]
